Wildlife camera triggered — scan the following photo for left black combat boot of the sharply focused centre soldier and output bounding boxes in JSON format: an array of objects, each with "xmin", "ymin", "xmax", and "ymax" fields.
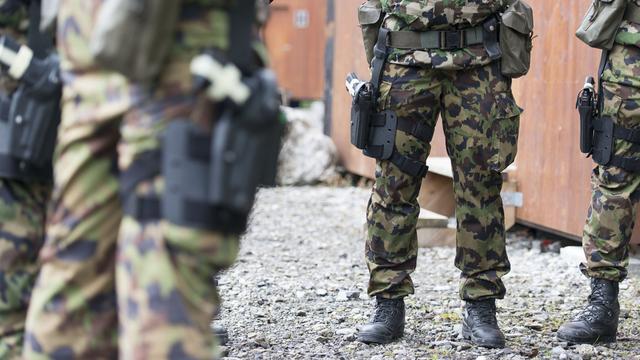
[{"xmin": 358, "ymin": 297, "xmax": 404, "ymax": 344}]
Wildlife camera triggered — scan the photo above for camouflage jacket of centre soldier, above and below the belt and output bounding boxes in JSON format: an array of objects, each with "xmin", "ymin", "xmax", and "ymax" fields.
[{"xmin": 381, "ymin": 0, "xmax": 510, "ymax": 70}]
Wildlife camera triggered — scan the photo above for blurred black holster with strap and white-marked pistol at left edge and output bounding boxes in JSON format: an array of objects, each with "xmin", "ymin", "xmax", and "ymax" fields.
[{"xmin": 0, "ymin": 1, "xmax": 62, "ymax": 182}]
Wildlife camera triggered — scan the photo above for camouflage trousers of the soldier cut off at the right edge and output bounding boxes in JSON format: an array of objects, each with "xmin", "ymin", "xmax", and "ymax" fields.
[{"xmin": 580, "ymin": 45, "xmax": 640, "ymax": 281}]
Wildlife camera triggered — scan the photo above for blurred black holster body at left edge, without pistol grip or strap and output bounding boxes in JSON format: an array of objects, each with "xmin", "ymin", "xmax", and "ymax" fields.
[{"xmin": 0, "ymin": 55, "xmax": 62, "ymax": 182}]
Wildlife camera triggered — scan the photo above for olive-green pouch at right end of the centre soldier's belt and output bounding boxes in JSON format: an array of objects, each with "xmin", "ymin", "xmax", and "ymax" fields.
[{"xmin": 500, "ymin": 1, "xmax": 533, "ymax": 79}]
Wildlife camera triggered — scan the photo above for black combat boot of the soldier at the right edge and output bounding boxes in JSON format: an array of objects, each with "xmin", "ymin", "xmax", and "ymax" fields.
[{"xmin": 557, "ymin": 279, "xmax": 620, "ymax": 344}]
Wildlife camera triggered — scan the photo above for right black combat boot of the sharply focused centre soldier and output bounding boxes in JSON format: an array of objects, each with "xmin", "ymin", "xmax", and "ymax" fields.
[{"xmin": 462, "ymin": 299, "xmax": 505, "ymax": 348}]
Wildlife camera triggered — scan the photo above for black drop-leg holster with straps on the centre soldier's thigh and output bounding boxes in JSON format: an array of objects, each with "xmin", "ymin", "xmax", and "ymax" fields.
[{"xmin": 347, "ymin": 28, "xmax": 433, "ymax": 177}]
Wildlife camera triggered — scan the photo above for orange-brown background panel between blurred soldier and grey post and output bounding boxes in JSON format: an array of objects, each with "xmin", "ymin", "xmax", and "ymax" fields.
[{"xmin": 264, "ymin": 0, "xmax": 327, "ymax": 100}]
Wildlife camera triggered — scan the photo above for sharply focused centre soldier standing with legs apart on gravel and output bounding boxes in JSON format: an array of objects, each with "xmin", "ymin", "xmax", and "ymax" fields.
[{"xmin": 358, "ymin": 0, "xmax": 533, "ymax": 348}]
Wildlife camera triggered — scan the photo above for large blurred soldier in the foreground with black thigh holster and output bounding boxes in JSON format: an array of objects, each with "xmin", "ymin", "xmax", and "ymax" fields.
[{"xmin": 24, "ymin": 0, "xmax": 277, "ymax": 359}]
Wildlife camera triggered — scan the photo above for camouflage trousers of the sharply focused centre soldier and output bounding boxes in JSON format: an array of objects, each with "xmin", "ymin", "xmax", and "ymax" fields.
[{"xmin": 365, "ymin": 63, "xmax": 521, "ymax": 300}]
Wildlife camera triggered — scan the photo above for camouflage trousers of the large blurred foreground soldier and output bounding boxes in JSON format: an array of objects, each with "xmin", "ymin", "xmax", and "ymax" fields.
[{"xmin": 24, "ymin": 75, "xmax": 238, "ymax": 359}]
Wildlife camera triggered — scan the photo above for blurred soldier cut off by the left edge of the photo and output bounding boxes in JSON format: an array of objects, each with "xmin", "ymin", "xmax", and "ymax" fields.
[{"xmin": 0, "ymin": 0, "xmax": 58, "ymax": 359}]
